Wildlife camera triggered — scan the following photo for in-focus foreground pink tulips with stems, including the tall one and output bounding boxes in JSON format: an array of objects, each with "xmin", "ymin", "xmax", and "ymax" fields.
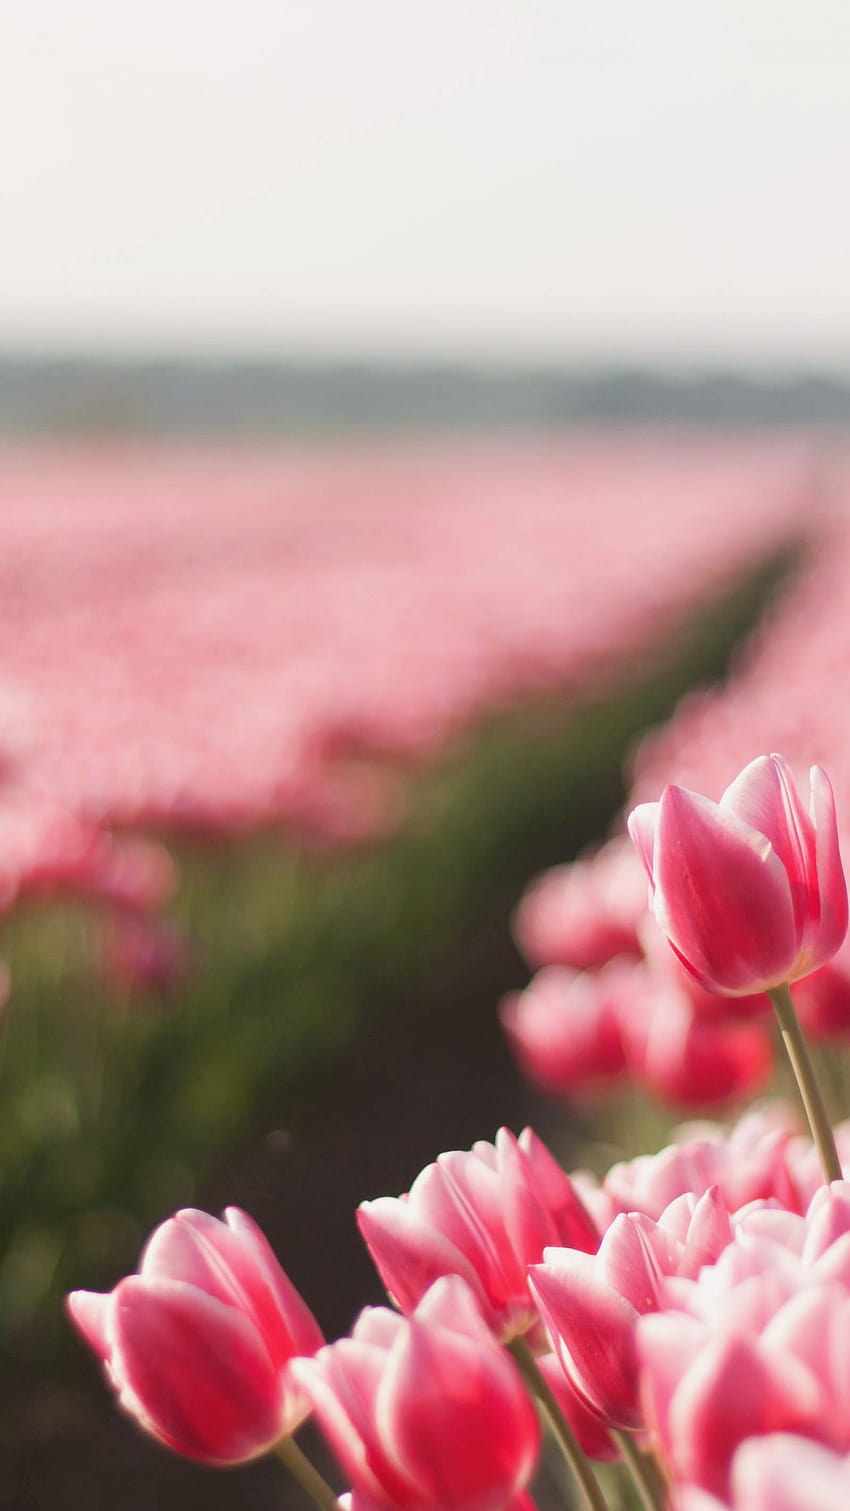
[{"xmin": 69, "ymin": 757, "xmax": 850, "ymax": 1511}]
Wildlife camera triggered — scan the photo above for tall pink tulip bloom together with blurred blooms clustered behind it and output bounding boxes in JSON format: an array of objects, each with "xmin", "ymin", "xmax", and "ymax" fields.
[{"xmin": 501, "ymin": 756, "xmax": 850, "ymax": 1108}]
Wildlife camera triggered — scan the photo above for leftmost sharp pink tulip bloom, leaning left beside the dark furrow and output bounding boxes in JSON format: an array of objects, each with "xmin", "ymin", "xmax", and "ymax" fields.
[{"xmin": 68, "ymin": 1207, "xmax": 323, "ymax": 1464}]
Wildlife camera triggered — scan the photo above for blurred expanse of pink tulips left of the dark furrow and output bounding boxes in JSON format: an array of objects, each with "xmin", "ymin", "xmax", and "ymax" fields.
[{"xmin": 0, "ymin": 438, "xmax": 809, "ymax": 984}]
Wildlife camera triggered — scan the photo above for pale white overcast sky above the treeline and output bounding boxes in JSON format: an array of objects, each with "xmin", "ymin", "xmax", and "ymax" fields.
[{"xmin": 0, "ymin": 0, "xmax": 850, "ymax": 369}]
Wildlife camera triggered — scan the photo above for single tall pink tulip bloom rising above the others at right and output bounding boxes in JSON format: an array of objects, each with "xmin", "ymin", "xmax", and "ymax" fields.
[{"xmin": 628, "ymin": 756, "xmax": 847, "ymax": 997}]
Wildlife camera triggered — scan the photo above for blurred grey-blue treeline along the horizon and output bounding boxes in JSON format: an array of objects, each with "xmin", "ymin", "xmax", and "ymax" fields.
[{"xmin": 0, "ymin": 354, "xmax": 850, "ymax": 435}]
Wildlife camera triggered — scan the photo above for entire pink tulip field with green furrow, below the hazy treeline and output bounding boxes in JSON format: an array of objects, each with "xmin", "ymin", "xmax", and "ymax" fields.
[{"xmin": 6, "ymin": 431, "xmax": 850, "ymax": 1511}]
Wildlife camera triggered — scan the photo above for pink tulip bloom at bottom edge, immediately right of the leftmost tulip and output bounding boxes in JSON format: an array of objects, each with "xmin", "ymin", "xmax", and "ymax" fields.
[{"xmin": 293, "ymin": 1275, "xmax": 539, "ymax": 1511}]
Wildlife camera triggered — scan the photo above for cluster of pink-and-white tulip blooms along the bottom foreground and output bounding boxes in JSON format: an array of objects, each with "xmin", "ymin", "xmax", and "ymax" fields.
[{"xmin": 69, "ymin": 1105, "xmax": 850, "ymax": 1511}]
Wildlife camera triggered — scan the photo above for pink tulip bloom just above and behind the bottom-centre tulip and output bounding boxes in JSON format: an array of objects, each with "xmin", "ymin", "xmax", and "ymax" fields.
[{"xmin": 358, "ymin": 1129, "xmax": 599, "ymax": 1340}]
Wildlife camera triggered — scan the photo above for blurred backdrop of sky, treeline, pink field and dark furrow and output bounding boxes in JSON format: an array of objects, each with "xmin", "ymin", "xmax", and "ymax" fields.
[{"xmin": 0, "ymin": 0, "xmax": 850, "ymax": 1511}]
